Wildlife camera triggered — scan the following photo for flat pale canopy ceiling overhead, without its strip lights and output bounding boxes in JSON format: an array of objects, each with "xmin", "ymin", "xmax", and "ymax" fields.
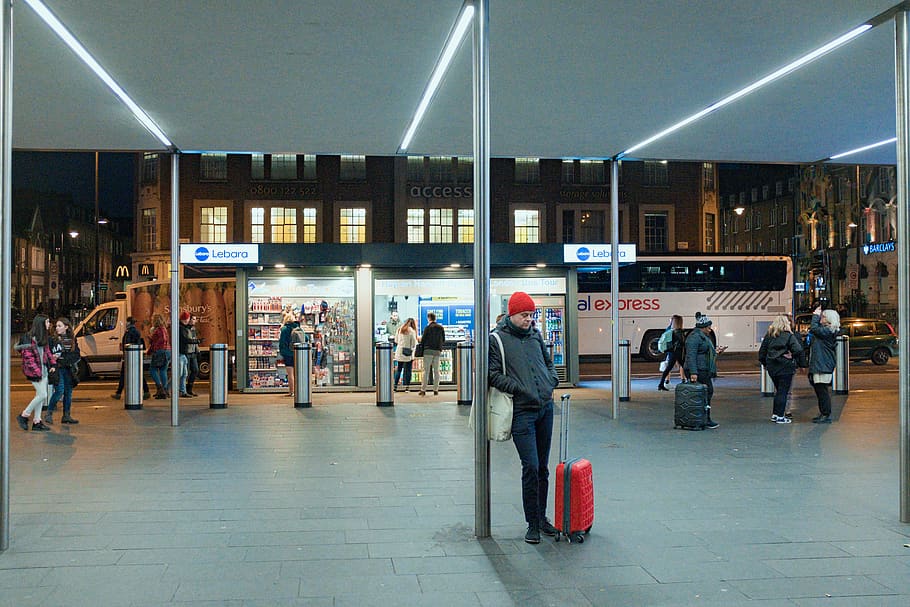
[{"xmin": 13, "ymin": 0, "xmax": 896, "ymax": 163}]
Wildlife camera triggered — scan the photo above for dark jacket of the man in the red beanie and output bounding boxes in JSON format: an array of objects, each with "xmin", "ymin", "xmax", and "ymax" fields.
[{"xmin": 488, "ymin": 316, "xmax": 559, "ymax": 410}]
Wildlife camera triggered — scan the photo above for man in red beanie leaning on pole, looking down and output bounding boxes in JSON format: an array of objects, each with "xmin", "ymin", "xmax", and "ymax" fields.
[{"xmin": 489, "ymin": 291, "xmax": 559, "ymax": 544}]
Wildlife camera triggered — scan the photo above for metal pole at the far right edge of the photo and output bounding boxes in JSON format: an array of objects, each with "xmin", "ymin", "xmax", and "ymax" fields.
[{"xmin": 894, "ymin": 10, "xmax": 910, "ymax": 523}]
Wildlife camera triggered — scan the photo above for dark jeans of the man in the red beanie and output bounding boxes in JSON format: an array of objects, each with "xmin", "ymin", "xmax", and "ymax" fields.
[{"xmin": 512, "ymin": 401, "xmax": 553, "ymax": 525}]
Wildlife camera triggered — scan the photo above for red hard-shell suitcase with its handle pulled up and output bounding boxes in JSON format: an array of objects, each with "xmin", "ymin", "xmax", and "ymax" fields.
[{"xmin": 553, "ymin": 394, "xmax": 594, "ymax": 543}]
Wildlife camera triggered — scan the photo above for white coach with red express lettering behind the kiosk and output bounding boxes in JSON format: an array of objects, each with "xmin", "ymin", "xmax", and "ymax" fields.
[{"xmin": 578, "ymin": 255, "xmax": 793, "ymax": 360}]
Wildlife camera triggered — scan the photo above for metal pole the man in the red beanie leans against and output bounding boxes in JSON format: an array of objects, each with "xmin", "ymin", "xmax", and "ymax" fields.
[{"xmin": 472, "ymin": 0, "xmax": 490, "ymax": 537}]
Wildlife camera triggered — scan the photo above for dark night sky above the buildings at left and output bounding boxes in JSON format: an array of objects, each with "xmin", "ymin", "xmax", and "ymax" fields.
[{"xmin": 13, "ymin": 152, "xmax": 135, "ymax": 217}]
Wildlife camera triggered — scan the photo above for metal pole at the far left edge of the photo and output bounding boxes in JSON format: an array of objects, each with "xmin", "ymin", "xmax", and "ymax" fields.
[{"xmin": 0, "ymin": 0, "xmax": 13, "ymax": 552}]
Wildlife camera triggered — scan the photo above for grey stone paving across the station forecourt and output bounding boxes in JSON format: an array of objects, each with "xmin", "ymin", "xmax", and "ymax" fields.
[{"xmin": 0, "ymin": 375, "xmax": 910, "ymax": 607}]
